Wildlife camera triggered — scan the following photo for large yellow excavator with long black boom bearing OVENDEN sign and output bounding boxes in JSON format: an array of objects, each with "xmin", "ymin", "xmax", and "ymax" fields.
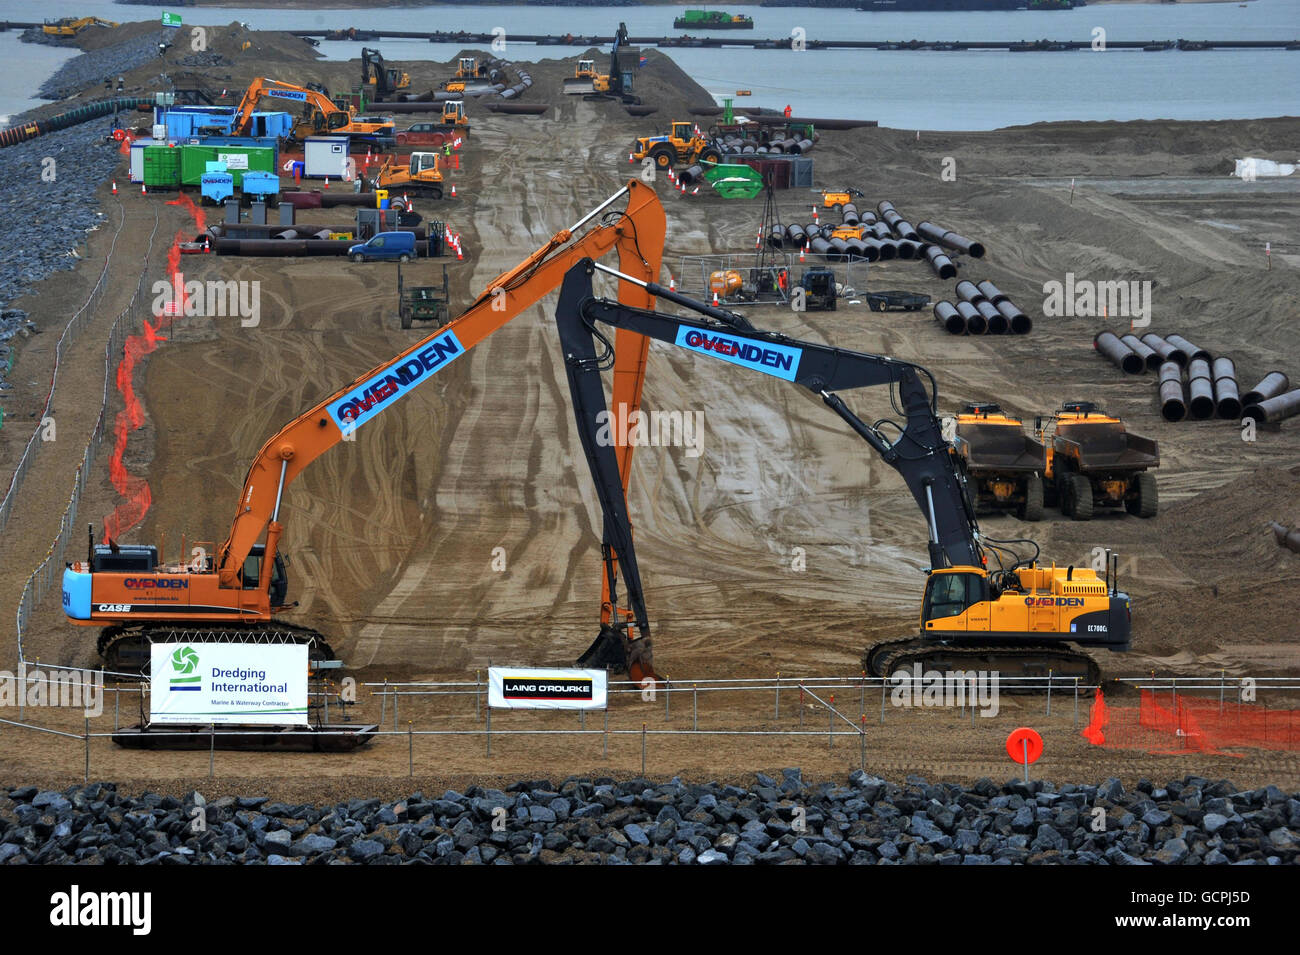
[{"xmin": 555, "ymin": 261, "xmax": 1131, "ymax": 683}]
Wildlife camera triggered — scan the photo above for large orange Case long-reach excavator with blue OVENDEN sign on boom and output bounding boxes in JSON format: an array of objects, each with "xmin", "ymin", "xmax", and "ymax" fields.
[{"xmin": 62, "ymin": 179, "xmax": 667, "ymax": 680}]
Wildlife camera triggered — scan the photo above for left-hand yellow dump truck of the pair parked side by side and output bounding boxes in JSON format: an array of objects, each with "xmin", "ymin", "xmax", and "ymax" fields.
[{"xmin": 953, "ymin": 403, "xmax": 1048, "ymax": 521}]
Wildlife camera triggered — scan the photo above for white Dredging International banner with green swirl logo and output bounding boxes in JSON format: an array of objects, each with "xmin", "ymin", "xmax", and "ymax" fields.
[{"xmin": 150, "ymin": 643, "xmax": 307, "ymax": 726}]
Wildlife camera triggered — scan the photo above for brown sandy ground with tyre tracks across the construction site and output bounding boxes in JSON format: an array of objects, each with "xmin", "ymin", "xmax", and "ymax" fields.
[{"xmin": 0, "ymin": 39, "xmax": 1300, "ymax": 794}]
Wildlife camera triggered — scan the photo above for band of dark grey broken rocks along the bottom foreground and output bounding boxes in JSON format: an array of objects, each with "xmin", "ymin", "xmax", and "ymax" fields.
[{"xmin": 0, "ymin": 769, "xmax": 1300, "ymax": 865}]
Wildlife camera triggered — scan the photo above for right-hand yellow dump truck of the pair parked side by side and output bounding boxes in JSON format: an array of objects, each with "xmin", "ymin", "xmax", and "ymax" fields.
[{"xmin": 1037, "ymin": 401, "xmax": 1160, "ymax": 521}]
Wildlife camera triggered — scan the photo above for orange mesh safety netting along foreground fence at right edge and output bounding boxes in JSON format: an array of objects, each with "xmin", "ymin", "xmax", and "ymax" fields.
[{"xmin": 1080, "ymin": 689, "xmax": 1300, "ymax": 755}]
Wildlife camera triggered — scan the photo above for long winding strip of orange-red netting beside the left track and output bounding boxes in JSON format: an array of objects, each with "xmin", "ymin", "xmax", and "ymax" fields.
[{"xmin": 104, "ymin": 195, "xmax": 205, "ymax": 543}]
